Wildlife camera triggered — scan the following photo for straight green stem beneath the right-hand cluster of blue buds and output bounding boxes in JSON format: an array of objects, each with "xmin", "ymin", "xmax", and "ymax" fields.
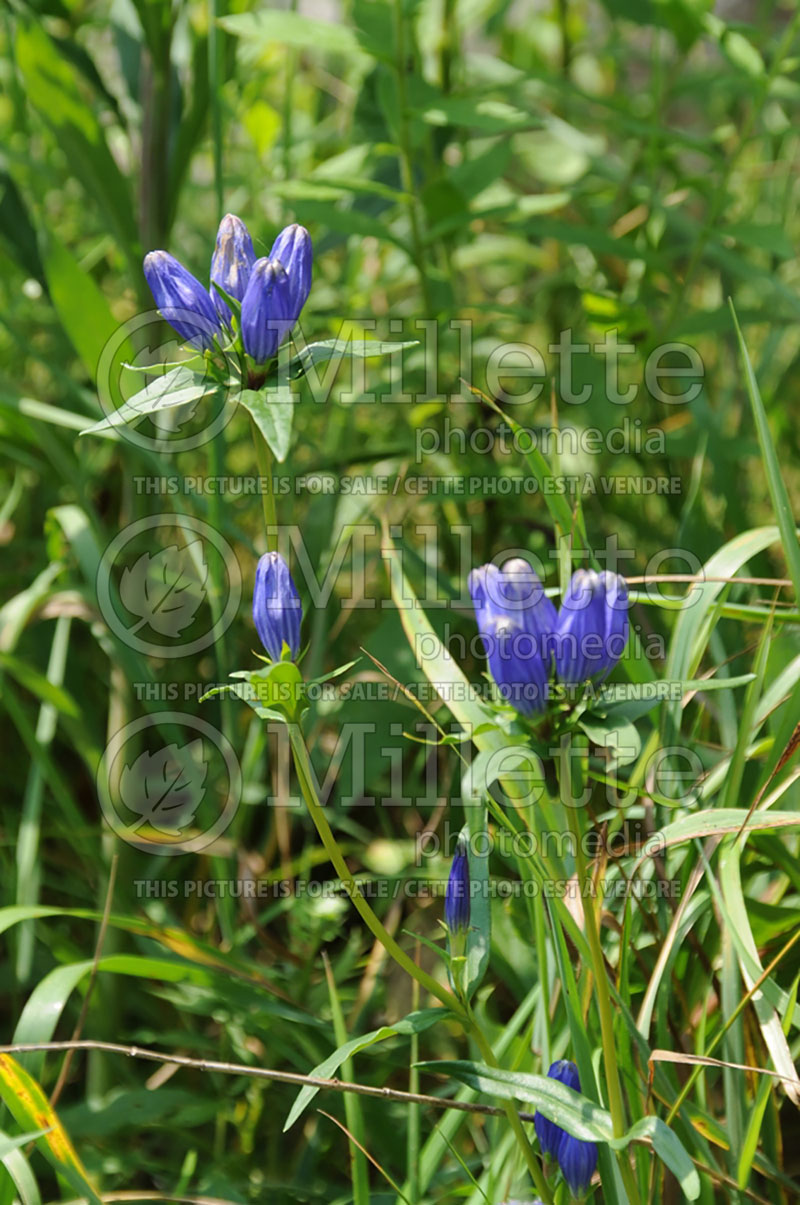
[{"xmin": 559, "ymin": 740, "xmax": 639, "ymax": 1205}]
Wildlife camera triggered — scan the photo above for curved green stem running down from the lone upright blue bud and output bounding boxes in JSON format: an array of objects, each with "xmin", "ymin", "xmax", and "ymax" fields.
[{"xmin": 289, "ymin": 723, "xmax": 553, "ymax": 1205}]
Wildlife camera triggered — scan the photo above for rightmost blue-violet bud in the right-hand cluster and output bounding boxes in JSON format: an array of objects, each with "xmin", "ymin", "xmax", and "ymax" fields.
[{"xmin": 554, "ymin": 569, "xmax": 629, "ymax": 686}]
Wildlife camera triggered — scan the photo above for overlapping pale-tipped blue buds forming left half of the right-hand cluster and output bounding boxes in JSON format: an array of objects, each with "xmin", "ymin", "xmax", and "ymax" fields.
[{"xmin": 469, "ymin": 558, "xmax": 557, "ymax": 715}]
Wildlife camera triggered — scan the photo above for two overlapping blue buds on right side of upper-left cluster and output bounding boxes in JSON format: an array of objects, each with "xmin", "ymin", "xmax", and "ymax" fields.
[{"xmin": 242, "ymin": 225, "xmax": 312, "ymax": 364}]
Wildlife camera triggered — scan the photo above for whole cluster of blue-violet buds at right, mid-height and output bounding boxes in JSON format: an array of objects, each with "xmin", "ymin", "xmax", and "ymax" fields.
[{"xmin": 469, "ymin": 557, "xmax": 629, "ymax": 715}]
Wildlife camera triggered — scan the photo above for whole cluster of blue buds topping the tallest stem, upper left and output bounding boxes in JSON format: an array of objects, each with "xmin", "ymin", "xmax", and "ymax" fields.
[{"xmin": 145, "ymin": 213, "xmax": 312, "ymax": 364}]
